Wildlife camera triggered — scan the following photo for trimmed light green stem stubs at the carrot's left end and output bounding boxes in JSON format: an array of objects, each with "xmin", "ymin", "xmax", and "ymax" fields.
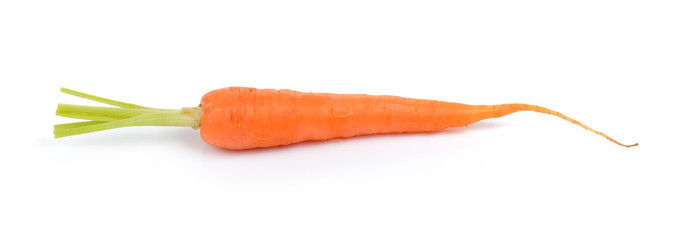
[{"xmin": 53, "ymin": 88, "xmax": 201, "ymax": 138}]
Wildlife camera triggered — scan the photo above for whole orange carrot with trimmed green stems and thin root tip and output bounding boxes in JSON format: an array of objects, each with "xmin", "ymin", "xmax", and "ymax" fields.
[{"xmin": 54, "ymin": 87, "xmax": 637, "ymax": 150}]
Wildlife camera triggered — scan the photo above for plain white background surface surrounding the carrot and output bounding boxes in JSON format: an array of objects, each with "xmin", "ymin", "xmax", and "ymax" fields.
[{"xmin": 0, "ymin": 0, "xmax": 690, "ymax": 239}]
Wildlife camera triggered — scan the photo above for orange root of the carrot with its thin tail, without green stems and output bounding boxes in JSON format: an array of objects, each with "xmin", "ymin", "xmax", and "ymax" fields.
[{"xmin": 200, "ymin": 87, "xmax": 632, "ymax": 149}]
